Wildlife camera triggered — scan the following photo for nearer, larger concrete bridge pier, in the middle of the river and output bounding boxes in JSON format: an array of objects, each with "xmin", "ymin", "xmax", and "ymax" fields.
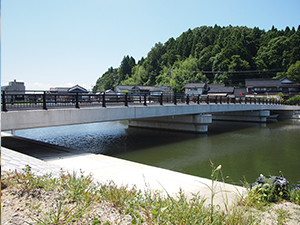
[{"xmin": 129, "ymin": 114, "xmax": 212, "ymax": 133}]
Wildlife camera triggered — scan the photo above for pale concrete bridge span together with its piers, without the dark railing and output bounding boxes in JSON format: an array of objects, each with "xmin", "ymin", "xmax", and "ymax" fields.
[{"xmin": 1, "ymin": 100, "xmax": 300, "ymax": 132}]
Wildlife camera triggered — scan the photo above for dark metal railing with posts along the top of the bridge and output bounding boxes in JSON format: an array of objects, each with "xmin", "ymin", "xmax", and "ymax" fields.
[{"xmin": 1, "ymin": 91, "xmax": 285, "ymax": 111}]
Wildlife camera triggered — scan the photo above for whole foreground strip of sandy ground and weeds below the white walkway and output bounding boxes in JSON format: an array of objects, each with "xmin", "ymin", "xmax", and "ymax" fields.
[{"xmin": 1, "ymin": 164, "xmax": 300, "ymax": 224}]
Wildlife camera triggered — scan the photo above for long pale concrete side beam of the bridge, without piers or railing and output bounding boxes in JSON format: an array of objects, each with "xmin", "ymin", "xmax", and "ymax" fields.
[{"xmin": 1, "ymin": 104, "xmax": 300, "ymax": 130}]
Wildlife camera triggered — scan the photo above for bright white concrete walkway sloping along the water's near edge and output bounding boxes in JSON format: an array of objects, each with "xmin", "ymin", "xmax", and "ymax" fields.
[{"xmin": 1, "ymin": 133, "xmax": 246, "ymax": 205}]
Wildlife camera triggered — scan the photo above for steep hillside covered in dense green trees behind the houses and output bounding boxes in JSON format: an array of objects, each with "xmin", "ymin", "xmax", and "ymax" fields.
[{"xmin": 93, "ymin": 25, "xmax": 300, "ymax": 92}]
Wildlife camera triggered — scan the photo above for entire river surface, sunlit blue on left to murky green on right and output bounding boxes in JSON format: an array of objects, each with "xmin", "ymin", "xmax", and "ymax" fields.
[{"xmin": 16, "ymin": 120, "xmax": 300, "ymax": 185}]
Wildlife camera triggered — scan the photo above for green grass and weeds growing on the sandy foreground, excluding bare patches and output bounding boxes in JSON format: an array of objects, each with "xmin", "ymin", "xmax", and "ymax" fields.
[{"xmin": 2, "ymin": 164, "xmax": 300, "ymax": 224}]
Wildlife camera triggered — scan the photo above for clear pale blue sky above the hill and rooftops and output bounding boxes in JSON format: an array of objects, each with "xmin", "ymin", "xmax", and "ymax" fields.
[{"xmin": 1, "ymin": 0, "xmax": 300, "ymax": 90}]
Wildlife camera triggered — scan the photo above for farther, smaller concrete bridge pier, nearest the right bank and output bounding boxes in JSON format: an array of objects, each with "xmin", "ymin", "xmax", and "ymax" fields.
[{"xmin": 212, "ymin": 110, "xmax": 270, "ymax": 123}]
